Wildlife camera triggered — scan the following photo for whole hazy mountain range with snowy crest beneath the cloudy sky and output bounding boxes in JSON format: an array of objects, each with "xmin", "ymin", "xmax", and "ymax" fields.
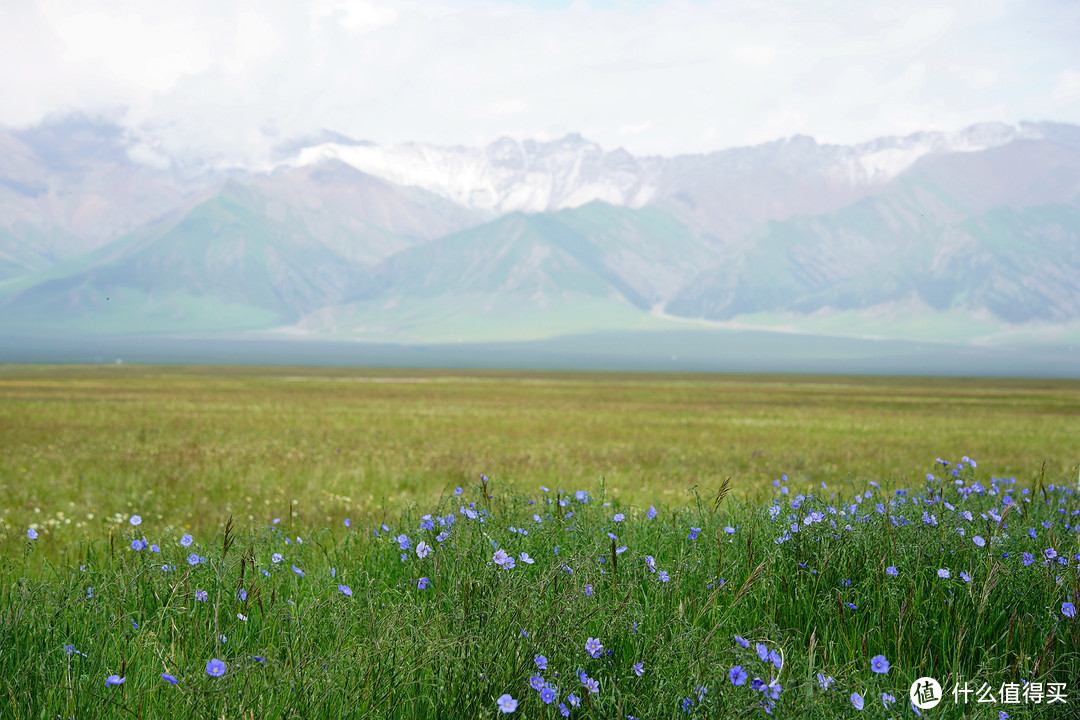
[{"xmin": 0, "ymin": 117, "xmax": 1080, "ymax": 367}]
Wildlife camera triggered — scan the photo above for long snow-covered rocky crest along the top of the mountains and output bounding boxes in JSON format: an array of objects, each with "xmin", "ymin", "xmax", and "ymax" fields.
[{"xmin": 282, "ymin": 123, "xmax": 1045, "ymax": 215}]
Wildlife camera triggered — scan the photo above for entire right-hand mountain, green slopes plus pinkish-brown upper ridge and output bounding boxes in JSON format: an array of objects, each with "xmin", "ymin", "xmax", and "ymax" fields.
[{"xmin": 665, "ymin": 142, "xmax": 1080, "ymax": 332}]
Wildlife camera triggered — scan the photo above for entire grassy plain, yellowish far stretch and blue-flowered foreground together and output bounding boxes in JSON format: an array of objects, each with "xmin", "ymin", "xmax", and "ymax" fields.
[{"xmin": 0, "ymin": 366, "xmax": 1080, "ymax": 720}]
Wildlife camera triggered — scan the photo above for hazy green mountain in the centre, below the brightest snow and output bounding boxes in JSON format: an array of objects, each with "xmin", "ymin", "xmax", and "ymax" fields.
[{"xmin": 297, "ymin": 203, "xmax": 715, "ymax": 342}]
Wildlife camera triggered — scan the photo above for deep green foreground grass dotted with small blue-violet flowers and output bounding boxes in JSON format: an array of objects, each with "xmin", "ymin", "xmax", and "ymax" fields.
[{"xmin": 0, "ymin": 458, "xmax": 1080, "ymax": 720}]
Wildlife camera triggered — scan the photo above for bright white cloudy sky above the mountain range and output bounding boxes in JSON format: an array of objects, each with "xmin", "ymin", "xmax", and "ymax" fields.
[{"xmin": 0, "ymin": 0, "xmax": 1080, "ymax": 162}]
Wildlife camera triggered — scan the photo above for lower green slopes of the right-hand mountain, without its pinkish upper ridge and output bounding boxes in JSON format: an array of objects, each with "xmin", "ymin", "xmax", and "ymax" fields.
[{"xmin": 666, "ymin": 195, "xmax": 1080, "ymax": 324}]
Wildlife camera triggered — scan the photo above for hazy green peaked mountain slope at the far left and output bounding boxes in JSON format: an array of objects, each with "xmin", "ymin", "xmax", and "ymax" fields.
[{"xmin": 0, "ymin": 186, "xmax": 360, "ymax": 332}]
